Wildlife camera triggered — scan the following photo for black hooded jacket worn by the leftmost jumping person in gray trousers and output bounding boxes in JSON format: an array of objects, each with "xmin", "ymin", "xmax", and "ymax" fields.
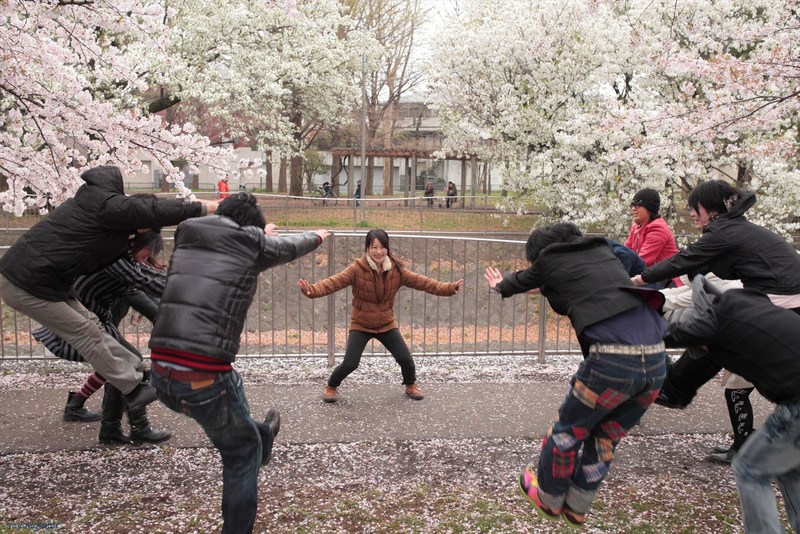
[{"xmin": 0, "ymin": 166, "xmax": 206, "ymax": 301}]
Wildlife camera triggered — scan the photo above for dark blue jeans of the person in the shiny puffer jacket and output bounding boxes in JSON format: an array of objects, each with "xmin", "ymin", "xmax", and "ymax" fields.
[{"xmin": 150, "ymin": 371, "xmax": 274, "ymax": 534}]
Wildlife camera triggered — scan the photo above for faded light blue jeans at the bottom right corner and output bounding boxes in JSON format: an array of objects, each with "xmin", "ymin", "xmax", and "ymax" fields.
[{"xmin": 733, "ymin": 401, "xmax": 800, "ymax": 533}]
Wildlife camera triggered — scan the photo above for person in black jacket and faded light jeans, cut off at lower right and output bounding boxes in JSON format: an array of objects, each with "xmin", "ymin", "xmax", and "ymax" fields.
[{"xmin": 669, "ymin": 276, "xmax": 800, "ymax": 533}]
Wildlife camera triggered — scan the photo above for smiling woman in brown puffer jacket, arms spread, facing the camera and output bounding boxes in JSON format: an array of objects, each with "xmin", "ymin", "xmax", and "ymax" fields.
[{"xmin": 297, "ymin": 229, "xmax": 464, "ymax": 402}]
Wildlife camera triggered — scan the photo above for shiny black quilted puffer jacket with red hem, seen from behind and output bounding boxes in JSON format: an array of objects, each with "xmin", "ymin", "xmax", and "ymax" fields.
[{"xmin": 150, "ymin": 216, "xmax": 319, "ymax": 362}]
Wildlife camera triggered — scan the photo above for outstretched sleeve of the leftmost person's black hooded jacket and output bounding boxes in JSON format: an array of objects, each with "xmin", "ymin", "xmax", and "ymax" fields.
[{"xmin": 98, "ymin": 194, "xmax": 206, "ymax": 230}]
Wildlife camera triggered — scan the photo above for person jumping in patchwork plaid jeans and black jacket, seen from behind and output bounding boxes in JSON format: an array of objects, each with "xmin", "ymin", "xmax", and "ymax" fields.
[{"xmin": 485, "ymin": 223, "xmax": 667, "ymax": 527}]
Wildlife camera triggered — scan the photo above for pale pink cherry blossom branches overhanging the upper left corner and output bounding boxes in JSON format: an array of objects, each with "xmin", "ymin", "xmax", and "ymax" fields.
[{"xmin": 0, "ymin": 0, "xmax": 229, "ymax": 214}]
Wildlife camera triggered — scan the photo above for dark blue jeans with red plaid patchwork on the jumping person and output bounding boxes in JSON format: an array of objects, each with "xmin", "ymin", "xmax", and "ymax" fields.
[{"xmin": 537, "ymin": 352, "xmax": 666, "ymax": 514}]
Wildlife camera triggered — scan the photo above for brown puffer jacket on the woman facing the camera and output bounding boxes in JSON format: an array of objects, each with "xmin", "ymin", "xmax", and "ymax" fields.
[{"xmin": 308, "ymin": 254, "xmax": 458, "ymax": 333}]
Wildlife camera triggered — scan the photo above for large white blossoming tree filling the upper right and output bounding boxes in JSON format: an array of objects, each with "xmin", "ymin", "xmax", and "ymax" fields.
[{"xmin": 430, "ymin": 0, "xmax": 800, "ymax": 237}]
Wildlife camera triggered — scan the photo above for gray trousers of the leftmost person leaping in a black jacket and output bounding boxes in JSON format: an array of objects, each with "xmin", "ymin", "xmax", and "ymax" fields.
[{"xmin": 0, "ymin": 275, "xmax": 144, "ymax": 394}]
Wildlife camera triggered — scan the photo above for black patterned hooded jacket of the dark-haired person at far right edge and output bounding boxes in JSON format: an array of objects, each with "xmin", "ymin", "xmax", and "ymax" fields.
[{"xmin": 642, "ymin": 192, "xmax": 800, "ymax": 295}]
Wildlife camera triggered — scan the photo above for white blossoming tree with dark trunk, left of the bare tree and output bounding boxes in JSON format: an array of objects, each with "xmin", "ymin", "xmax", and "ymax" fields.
[{"xmin": 163, "ymin": 0, "xmax": 369, "ymax": 195}]
